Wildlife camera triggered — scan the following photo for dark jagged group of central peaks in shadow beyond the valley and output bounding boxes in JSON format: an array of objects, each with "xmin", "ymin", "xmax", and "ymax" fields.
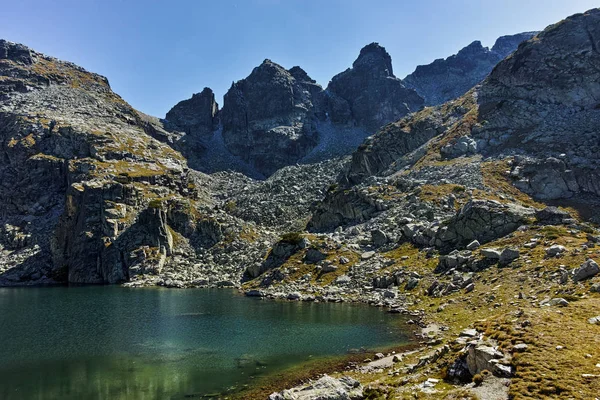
[{"xmin": 166, "ymin": 43, "xmax": 423, "ymax": 177}]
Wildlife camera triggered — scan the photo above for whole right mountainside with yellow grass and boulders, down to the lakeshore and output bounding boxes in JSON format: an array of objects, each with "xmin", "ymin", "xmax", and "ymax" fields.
[{"xmin": 245, "ymin": 9, "xmax": 600, "ymax": 399}]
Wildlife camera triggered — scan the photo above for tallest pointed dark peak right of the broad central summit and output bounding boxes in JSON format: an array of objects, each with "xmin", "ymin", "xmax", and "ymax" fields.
[{"xmin": 326, "ymin": 43, "xmax": 423, "ymax": 132}]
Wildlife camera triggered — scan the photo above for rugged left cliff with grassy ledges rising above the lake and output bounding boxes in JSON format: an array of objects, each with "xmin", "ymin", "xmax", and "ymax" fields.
[{"xmin": 0, "ymin": 41, "xmax": 205, "ymax": 283}]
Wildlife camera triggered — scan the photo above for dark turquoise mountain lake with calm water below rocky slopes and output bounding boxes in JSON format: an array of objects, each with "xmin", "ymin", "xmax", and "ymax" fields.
[{"xmin": 0, "ymin": 286, "xmax": 407, "ymax": 400}]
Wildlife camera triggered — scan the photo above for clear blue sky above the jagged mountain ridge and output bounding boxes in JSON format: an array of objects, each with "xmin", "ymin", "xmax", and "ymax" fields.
[{"xmin": 0, "ymin": 0, "xmax": 599, "ymax": 117}]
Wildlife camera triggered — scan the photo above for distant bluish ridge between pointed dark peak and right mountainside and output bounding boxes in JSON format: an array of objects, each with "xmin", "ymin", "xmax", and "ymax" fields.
[{"xmin": 404, "ymin": 32, "xmax": 538, "ymax": 106}]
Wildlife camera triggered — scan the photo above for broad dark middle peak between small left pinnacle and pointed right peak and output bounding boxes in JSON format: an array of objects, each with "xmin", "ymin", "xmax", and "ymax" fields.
[{"xmin": 221, "ymin": 60, "xmax": 320, "ymax": 175}]
